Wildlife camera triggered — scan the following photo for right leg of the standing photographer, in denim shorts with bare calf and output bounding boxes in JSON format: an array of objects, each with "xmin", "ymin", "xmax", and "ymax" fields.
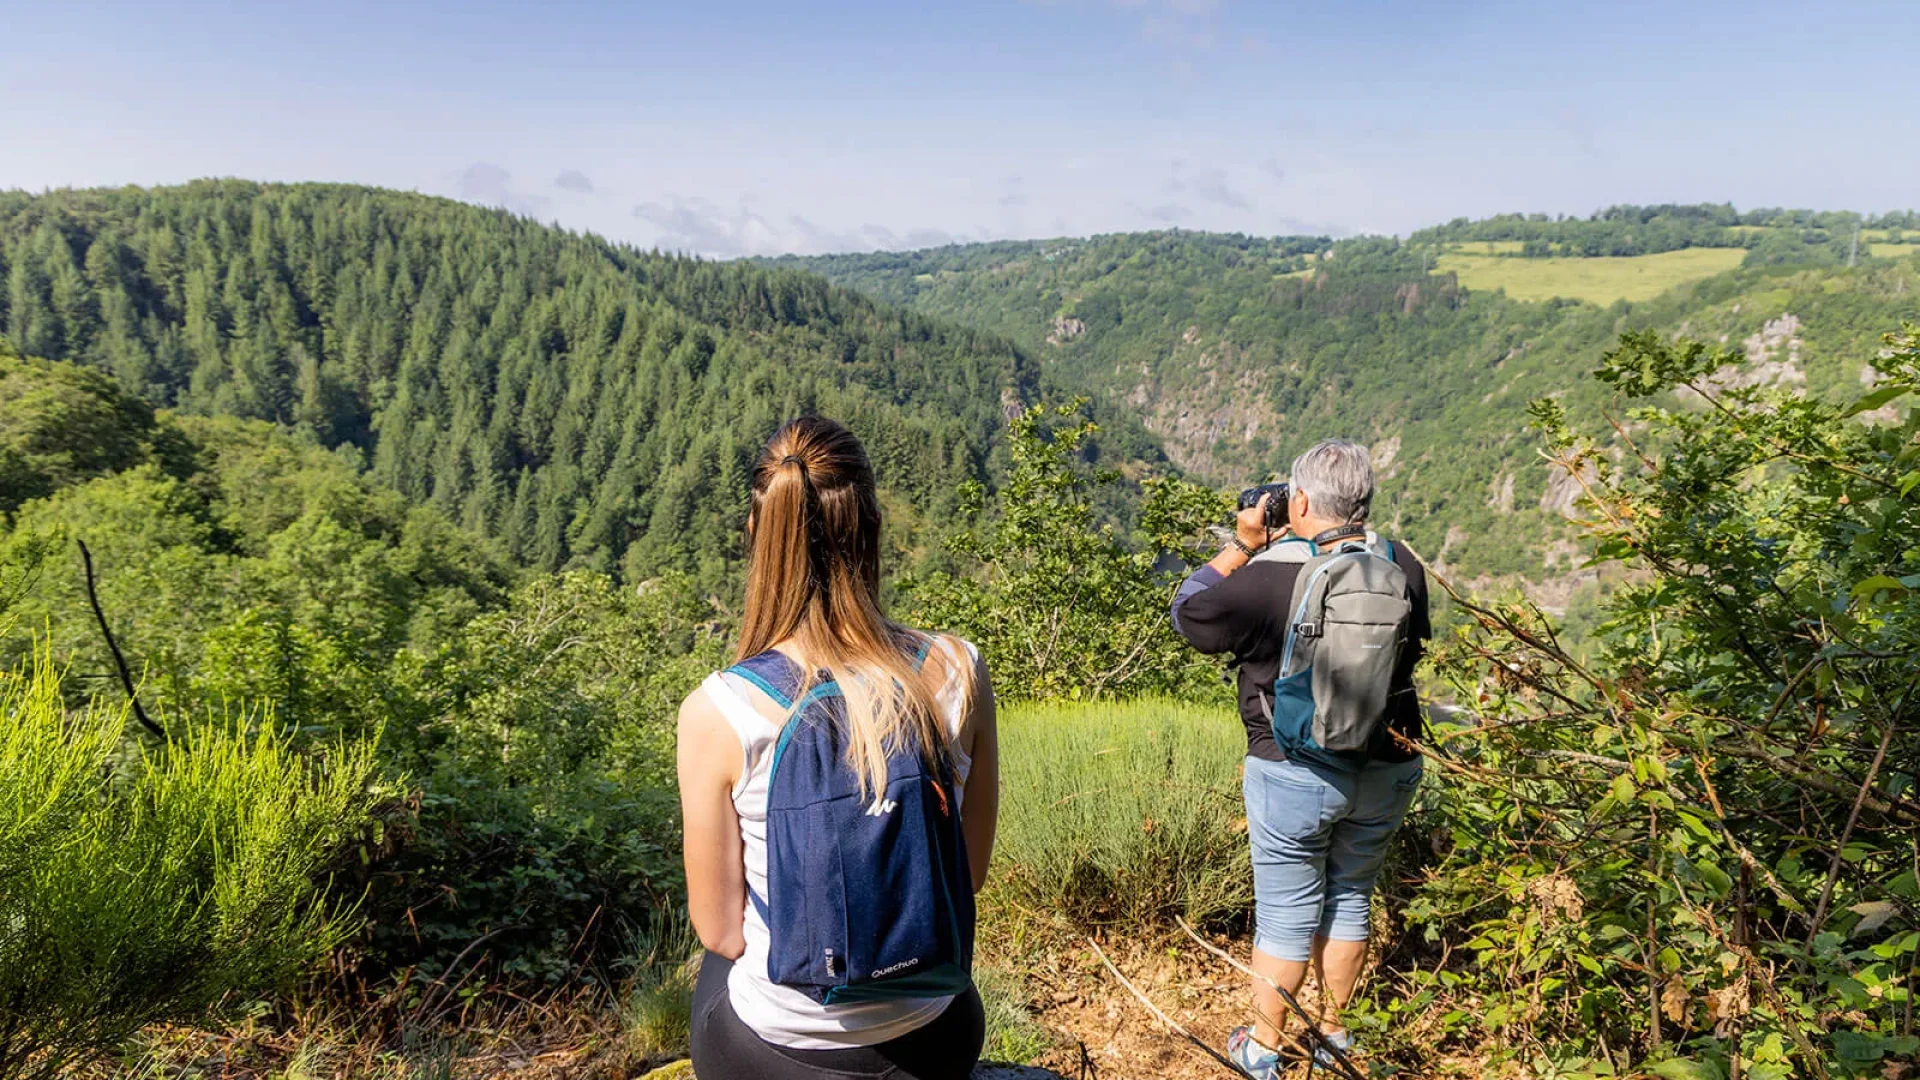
[{"xmin": 1313, "ymin": 759, "xmax": 1421, "ymax": 1034}]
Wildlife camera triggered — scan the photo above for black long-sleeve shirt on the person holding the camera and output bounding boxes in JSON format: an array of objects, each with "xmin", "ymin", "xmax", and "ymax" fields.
[{"xmin": 1173, "ymin": 540, "xmax": 1432, "ymax": 761}]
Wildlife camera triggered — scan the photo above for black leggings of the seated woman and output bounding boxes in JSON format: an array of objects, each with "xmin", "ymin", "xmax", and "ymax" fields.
[{"xmin": 693, "ymin": 953, "xmax": 987, "ymax": 1080}]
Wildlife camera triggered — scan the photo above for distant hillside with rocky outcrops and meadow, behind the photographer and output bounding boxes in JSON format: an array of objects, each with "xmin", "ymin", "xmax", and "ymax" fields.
[{"xmin": 783, "ymin": 208, "xmax": 1920, "ymax": 578}]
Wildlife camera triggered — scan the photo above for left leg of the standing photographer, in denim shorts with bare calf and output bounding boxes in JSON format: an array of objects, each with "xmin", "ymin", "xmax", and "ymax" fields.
[{"xmin": 1242, "ymin": 757, "xmax": 1346, "ymax": 1049}]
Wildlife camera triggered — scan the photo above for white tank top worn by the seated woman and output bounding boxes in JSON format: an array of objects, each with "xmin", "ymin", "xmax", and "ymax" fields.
[{"xmin": 701, "ymin": 638, "xmax": 979, "ymax": 1049}]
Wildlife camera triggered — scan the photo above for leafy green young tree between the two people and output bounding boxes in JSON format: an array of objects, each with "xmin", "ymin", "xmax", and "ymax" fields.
[{"xmin": 900, "ymin": 404, "xmax": 1227, "ymax": 700}]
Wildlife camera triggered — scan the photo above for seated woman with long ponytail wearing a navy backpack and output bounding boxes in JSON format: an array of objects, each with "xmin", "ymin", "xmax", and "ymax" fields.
[{"xmin": 678, "ymin": 417, "xmax": 998, "ymax": 1080}]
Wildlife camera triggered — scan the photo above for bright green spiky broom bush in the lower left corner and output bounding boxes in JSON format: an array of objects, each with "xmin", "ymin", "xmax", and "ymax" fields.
[{"xmin": 0, "ymin": 651, "xmax": 374, "ymax": 1080}]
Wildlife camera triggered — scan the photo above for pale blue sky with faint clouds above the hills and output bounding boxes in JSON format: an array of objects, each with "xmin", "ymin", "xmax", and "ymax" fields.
[{"xmin": 0, "ymin": 0, "xmax": 1920, "ymax": 258}]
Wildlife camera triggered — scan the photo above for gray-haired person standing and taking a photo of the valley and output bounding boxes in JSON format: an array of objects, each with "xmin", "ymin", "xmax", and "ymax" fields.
[{"xmin": 1173, "ymin": 440, "xmax": 1432, "ymax": 1080}]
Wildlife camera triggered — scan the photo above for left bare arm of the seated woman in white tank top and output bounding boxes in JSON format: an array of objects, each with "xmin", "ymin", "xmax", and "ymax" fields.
[{"xmin": 678, "ymin": 690, "xmax": 747, "ymax": 961}]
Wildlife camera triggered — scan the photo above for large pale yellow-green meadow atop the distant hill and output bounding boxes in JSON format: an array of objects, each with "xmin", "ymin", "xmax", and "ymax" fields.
[{"xmin": 1438, "ymin": 244, "xmax": 1747, "ymax": 306}]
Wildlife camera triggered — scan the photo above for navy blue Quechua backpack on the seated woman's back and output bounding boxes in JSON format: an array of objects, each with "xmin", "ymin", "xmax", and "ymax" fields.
[{"xmin": 728, "ymin": 640, "xmax": 973, "ymax": 1005}]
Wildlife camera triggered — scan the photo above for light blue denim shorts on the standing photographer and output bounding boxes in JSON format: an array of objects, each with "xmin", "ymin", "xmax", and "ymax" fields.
[{"xmin": 1242, "ymin": 757, "xmax": 1423, "ymax": 961}]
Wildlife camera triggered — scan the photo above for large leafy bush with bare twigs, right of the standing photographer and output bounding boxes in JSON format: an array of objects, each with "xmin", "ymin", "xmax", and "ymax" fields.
[{"xmin": 1409, "ymin": 322, "xmax": 1920, "ymax": 1076}]
